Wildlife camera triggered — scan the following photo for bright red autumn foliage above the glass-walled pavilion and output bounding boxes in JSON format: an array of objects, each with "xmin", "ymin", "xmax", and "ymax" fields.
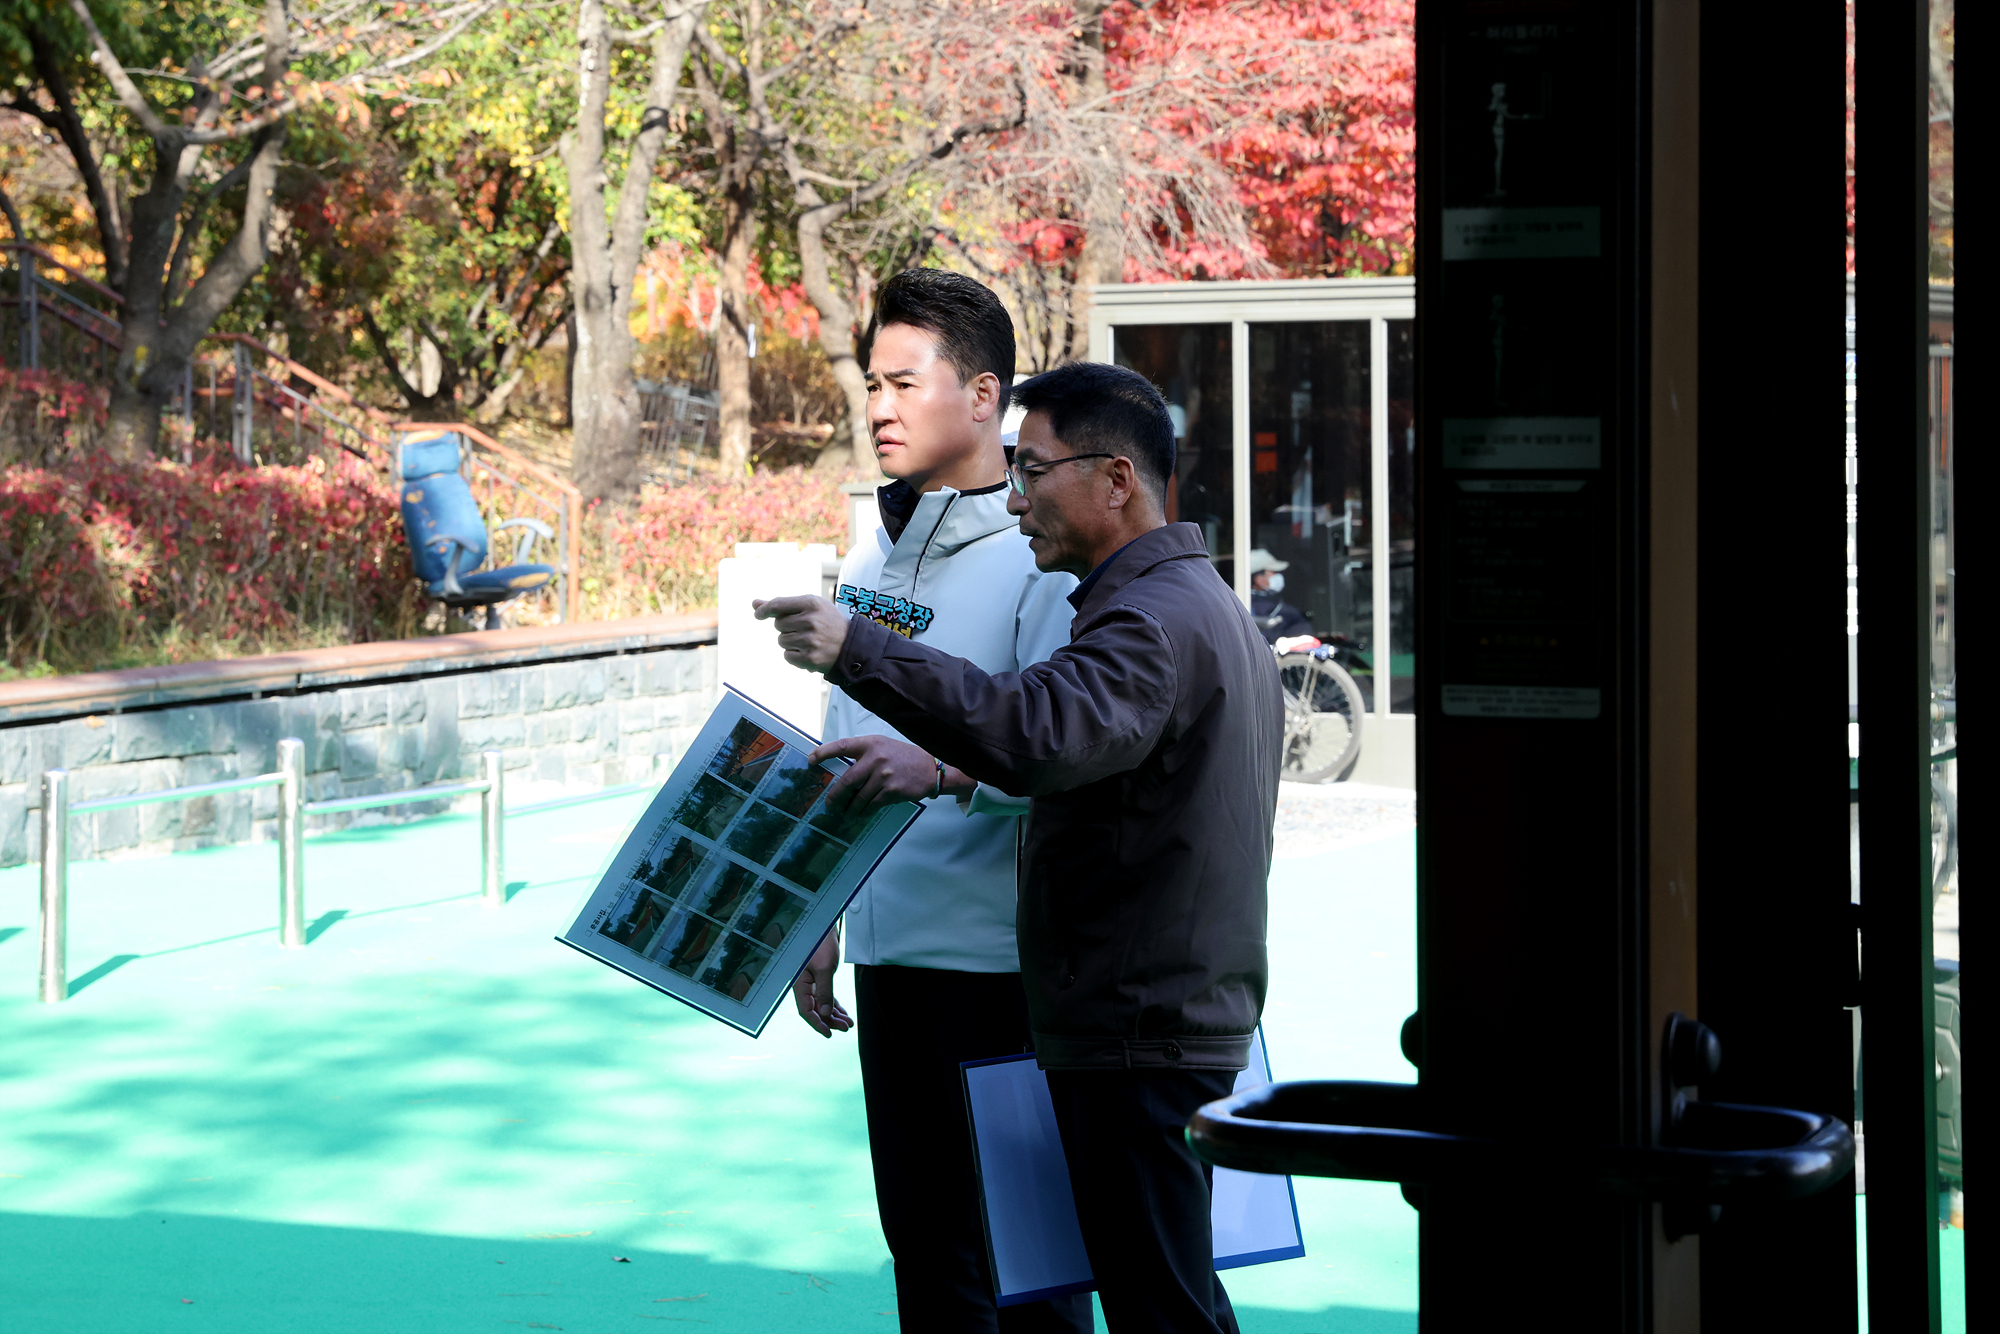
[{"xmin": 1002, "ymin": 0, "xmax": 1416, "ymax": 282}]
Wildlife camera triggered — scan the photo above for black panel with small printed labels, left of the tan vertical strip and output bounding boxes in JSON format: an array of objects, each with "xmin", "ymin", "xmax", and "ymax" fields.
[{"xmin": 1416, "ymin": 0, "xmax": 1694, "ymax": 1330}]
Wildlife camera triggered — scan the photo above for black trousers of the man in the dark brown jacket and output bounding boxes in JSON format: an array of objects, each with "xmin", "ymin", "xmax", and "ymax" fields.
[{"xmin": 1048, "ymin": 1070, "xmax": 1236, "ymax": 1334}]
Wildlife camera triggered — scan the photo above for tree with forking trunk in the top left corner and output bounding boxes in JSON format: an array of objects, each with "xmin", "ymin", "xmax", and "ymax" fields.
[{"xmin": 1, "ymin": 0, "xmax": 498, "ymax": 450}]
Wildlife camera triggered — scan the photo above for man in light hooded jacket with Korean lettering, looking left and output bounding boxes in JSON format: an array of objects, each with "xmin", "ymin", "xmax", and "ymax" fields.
[{"xmin": 794, "ymin": 268, "xmax": 1090, "ymax": 1334}]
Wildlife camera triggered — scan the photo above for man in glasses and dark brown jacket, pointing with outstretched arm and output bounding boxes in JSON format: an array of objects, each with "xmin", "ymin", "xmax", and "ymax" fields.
[{"xmin": 758, "ymin": 364, "xmax": 1284, "ymax": 1334}]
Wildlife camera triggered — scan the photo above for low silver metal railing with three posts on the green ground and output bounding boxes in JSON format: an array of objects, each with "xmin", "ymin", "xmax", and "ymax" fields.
[{"xmin": 38, "ymin": 736, "xmax": 506, "ymax": 1004}]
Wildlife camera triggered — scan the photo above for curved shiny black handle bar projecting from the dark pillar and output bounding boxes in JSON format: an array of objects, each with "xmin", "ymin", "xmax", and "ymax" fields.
[{"xmin": 1188, "ymin": 1080, "xmax": 1854, "ymax": 1204}]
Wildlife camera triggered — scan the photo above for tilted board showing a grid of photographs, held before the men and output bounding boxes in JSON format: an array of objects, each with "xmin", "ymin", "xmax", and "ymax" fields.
[{"xmin": 564, "ymin": 696, "xmax": 918, "ymax": 1032}]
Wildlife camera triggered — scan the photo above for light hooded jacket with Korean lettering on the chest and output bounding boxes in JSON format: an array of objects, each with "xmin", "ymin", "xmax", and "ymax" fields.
[{"xmin": 824, "ymin": 482, "xmax": 1076, "ymax": 972}]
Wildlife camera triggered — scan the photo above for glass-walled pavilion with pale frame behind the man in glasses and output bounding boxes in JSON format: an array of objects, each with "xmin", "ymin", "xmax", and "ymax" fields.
[{"xmin": 1090, "ymin": 278, "xmax": 1416, "ymax": 724}]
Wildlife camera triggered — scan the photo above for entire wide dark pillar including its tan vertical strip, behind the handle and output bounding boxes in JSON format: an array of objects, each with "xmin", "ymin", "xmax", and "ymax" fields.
[{"xmin": 1410, "ymin": 0, "xmax": 1864, "ymax": 1330}]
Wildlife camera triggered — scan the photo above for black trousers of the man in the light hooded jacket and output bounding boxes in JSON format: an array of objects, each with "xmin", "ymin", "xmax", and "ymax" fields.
[{"xmin": 854, "ymin": 964, "xmax": 1092, "ymax": 1334}]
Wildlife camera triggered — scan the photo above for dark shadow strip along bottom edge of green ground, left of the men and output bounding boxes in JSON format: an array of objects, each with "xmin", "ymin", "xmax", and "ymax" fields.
[{"xmin": 0, "ymin": 1212, "xmax": 896, "ymax": 1334}]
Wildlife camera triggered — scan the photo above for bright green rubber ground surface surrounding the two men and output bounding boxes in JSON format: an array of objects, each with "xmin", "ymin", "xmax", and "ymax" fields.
[{"xmin": 0, "ymin": 796, "xmax": 1416, "ymax": 1334}]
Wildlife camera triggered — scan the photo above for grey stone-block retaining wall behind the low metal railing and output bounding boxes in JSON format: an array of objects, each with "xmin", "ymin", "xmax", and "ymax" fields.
[{"xmin": 0, "ymin": 626, "xmax": 718, "ymax": 866}]
